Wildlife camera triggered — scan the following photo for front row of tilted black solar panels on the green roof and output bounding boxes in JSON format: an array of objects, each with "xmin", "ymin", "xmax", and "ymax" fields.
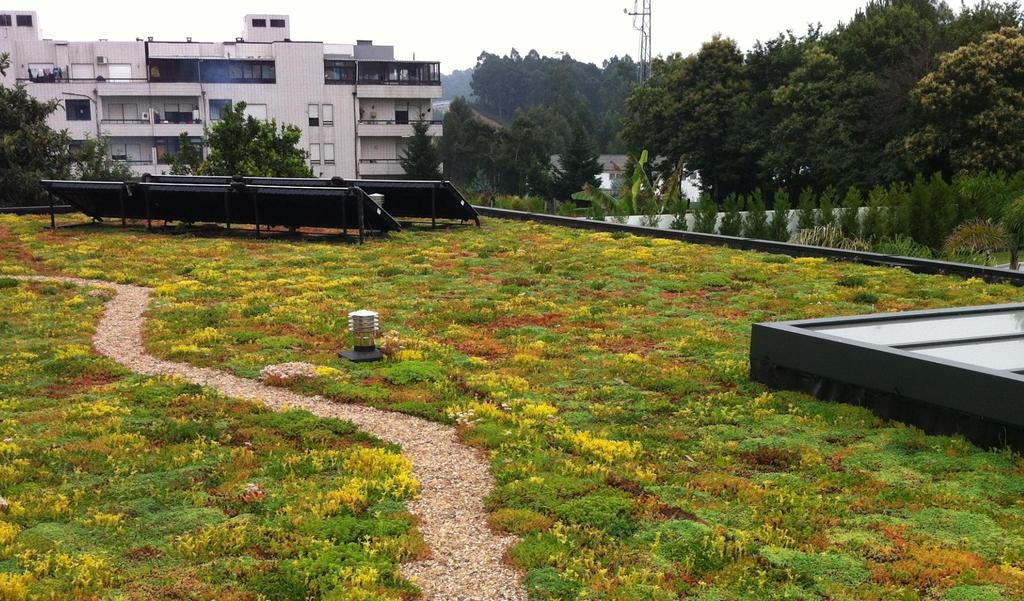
[{"xmin": 43, "ymin": 177, "xmax": 401, "ymax": 238}]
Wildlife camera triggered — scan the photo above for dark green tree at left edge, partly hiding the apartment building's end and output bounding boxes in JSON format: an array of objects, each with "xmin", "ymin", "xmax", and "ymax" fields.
[{"xmin": 0, "ymin": 49, "xmax": 71, "ymax": 206}]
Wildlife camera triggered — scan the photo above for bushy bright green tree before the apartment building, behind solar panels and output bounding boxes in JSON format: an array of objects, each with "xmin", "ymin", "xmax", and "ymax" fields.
[{"xmin": 199, "ymin": 102, "xmax": 312, "ymax": 177}]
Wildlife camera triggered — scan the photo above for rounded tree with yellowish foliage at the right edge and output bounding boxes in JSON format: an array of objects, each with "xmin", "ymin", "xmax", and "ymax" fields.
[{"xmin": 900, "ymin": 29, "xmax": 1024, "ymax": 175}]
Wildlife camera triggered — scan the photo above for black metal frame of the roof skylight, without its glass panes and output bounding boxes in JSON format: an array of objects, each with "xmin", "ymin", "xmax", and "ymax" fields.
[{"xmin": 751, "ymin": 305, "xmax": 1024, "ymax": 445}]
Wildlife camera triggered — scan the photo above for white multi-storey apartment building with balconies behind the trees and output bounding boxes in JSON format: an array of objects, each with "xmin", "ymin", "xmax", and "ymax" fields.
[{"xmin": 0, "ymin": 10, "xmax": 441, "ymax": 178}]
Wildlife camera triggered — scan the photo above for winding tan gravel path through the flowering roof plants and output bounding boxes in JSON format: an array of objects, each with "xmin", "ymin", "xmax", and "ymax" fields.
[{"xmin": 23, "ymin": 276, "xmax": 526, "ymax": 601}]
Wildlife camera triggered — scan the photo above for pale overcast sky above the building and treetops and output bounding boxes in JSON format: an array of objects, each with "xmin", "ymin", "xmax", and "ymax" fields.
[{"xmin": 31, "ymin": 0, "xmax": 991, "ymax": 73}]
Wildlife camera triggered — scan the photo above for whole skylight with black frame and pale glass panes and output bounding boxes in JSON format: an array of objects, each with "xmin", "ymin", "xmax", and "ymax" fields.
[{"xmin": 751, "ymin": 304, "xmax": 1024, "ymax": 450}]
